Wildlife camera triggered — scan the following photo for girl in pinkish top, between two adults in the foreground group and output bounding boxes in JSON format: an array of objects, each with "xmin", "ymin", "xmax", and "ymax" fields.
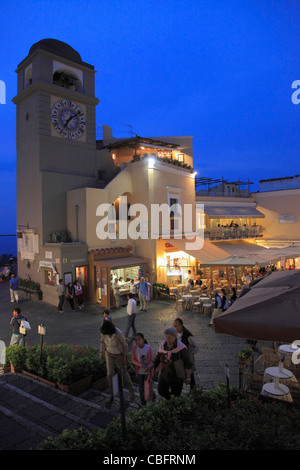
[{"xmin": 131, "ymin": 333, "xmax": 154, "ymax": 405}]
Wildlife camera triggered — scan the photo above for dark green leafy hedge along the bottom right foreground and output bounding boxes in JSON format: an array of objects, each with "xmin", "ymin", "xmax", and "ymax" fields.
[{"xmin": 40, "ymin": 384, "xmax": 300, "ymax": 451}]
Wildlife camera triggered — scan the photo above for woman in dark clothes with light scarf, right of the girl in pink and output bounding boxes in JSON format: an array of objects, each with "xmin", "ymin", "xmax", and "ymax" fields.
[{"xmin": 146, "ymin": 328, "xmax": 193, "ymax": 400}]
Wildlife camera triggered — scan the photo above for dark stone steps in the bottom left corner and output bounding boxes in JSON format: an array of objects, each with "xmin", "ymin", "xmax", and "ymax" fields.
[{"xmin": 0, "ymin": 374, "xmax": 118, "ymax": 450}]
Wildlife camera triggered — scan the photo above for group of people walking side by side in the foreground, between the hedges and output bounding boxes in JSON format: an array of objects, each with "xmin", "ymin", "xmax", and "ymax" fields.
[{"xmin": 100, "ymin": 311, "xmax": 198, "ymax": 405}]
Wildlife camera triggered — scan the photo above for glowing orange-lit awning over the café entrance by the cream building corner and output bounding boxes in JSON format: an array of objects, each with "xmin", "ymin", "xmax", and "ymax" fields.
[{"xmin": 164, "ymin": 238, "xmax": 229, "ymax": 263}]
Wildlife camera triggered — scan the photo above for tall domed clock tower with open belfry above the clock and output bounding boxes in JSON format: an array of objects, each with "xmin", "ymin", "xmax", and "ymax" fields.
[{"xmin": 13, "ymin": 39, "xmax": 99, "ymax": 302}]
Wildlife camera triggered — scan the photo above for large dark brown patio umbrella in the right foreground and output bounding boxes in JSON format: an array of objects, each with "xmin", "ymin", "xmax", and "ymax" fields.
[{"xmin": 213, "ymin": 270, "xmax": 300, "ymax": 343}]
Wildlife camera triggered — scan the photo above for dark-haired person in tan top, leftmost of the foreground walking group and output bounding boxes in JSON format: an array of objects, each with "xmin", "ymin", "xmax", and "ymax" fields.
[{"xmin": 100, "ymin": 321, "xmax": 135, "ymax": 403}]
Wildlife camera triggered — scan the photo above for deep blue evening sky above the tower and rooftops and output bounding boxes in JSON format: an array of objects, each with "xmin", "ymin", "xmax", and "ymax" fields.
[{"xmin": 0, "ymin": 0, "xmax": 300, "ymax": 254}]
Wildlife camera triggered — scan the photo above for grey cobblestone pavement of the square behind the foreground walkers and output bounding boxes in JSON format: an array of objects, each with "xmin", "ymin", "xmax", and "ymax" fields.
[{"xmin": 0, "ymin": 283, "xmax": 268, "ymax": 389}]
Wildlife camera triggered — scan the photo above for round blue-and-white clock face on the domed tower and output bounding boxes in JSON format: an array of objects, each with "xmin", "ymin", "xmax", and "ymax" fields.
[{"xmin": 51, "ymin": 98, "xmax": 86, "ymax": 140}]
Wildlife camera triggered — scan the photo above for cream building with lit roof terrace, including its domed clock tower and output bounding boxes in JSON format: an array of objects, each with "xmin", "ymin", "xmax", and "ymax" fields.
[{"xmin": 13, "ymin": 39, "xmax": 203, "ymax": 307}]
